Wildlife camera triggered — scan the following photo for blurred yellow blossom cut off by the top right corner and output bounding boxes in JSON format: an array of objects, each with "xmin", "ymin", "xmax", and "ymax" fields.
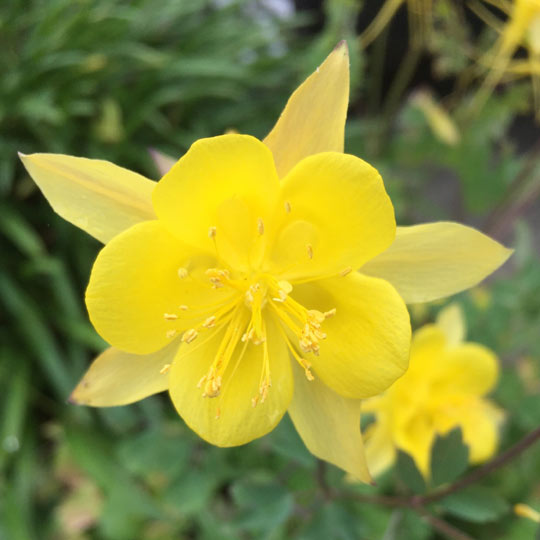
[{"xmin": 479, "ymin": 0, "xmax": 540, "ymax": 119}]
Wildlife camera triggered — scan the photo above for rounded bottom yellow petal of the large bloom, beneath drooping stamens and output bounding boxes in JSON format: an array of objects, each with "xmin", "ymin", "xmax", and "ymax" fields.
[{"xmin": 169, "ymin": 319, "xmax": 293, "ymax": 446}]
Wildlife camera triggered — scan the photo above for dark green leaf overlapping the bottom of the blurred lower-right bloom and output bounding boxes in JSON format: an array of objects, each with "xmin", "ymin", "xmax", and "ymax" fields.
[{"xmin": 431, "ymin": 428, "xmax": 469, "ymax": 487}]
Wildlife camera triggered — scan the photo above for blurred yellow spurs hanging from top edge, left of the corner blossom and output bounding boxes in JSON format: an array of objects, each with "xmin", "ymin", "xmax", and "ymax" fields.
[{"xmin": 360, "ymin": 0, "xmax": 433, "ymax": 47}]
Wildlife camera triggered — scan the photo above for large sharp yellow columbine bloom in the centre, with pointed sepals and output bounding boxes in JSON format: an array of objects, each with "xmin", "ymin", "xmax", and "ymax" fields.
[{"xmin": 22, "ymin": 43, "xmax": 510, "ymax": 480}]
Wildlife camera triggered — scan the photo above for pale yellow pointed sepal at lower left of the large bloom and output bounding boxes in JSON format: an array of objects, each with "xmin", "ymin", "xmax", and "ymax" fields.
[{"xmin": 69, "ymin": 344, "xmax": 173, "ymax": 407}]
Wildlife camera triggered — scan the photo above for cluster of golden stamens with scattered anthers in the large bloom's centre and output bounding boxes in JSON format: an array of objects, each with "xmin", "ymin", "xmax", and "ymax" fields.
[{"xmin": 158, "ymin": 220, "xmax": 351, "ymax": 418}]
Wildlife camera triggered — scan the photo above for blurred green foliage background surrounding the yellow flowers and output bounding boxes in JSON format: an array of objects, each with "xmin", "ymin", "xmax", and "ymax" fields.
[{"xmin": 0, "ymin": 0, "xmax": 540, "ymax": 540}]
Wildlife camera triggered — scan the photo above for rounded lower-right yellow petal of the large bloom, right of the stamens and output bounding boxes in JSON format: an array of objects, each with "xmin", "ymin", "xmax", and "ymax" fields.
[{"xmin": 291, "ymin": 273, "xmax": 411, "ymax": 399}]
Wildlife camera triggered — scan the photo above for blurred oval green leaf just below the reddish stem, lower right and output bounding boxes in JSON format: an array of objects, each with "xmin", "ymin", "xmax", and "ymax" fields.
[{"xmin": 441, "ymin": 486, "xmax": 509, "ymax": 523}]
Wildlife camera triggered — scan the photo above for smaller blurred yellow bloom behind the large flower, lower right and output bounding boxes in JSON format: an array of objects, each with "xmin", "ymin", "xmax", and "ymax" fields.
[{"xmin": 364, "ymin": 305, "xmax": 502, "ymax": 477}]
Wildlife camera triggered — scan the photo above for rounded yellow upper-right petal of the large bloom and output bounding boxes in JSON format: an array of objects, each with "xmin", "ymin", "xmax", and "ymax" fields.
[{"xmin": 269, "ymin": 152, "xmax": 395, "ymax": 280}]
